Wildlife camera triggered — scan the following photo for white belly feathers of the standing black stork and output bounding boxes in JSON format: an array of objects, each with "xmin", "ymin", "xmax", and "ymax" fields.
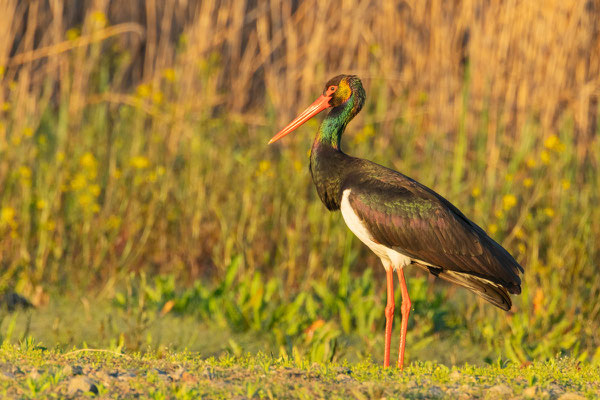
[{"xmin": 340, "ymin": 189, "xmax": 411, "ymax": 269}]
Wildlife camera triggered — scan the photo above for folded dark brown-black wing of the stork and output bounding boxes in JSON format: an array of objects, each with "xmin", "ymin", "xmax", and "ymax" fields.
[{"xmin": 343, "ymin": 166, "xmax": 523, "ymax": 302}]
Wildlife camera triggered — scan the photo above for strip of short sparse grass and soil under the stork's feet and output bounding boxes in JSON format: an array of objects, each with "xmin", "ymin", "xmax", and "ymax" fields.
[{"xmin": 0, "ymin": 341, "xmax": 600, "ymax": 399}]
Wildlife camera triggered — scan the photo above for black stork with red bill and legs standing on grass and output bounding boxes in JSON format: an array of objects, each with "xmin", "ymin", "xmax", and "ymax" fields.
[{"xmin": 269, "ymin": 75, "xmax": 523, "ymax": 369}]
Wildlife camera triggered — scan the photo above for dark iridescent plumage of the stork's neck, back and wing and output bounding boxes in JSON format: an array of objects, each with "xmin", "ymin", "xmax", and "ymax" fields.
[{"xmin": 310, "ymin": 77, "xmax": 523, "ymax": 310}]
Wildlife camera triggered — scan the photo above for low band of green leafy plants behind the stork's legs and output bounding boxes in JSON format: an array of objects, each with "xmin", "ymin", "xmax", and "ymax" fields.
[{"xmin": 0, "ymin": 259, "xmax": 598, "ymax": 366}]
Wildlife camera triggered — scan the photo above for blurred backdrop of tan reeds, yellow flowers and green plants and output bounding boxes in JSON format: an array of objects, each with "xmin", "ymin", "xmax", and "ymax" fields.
[{"xmin": 0, "ymin": 0, "xmax": 600, "ymax": 362}]
